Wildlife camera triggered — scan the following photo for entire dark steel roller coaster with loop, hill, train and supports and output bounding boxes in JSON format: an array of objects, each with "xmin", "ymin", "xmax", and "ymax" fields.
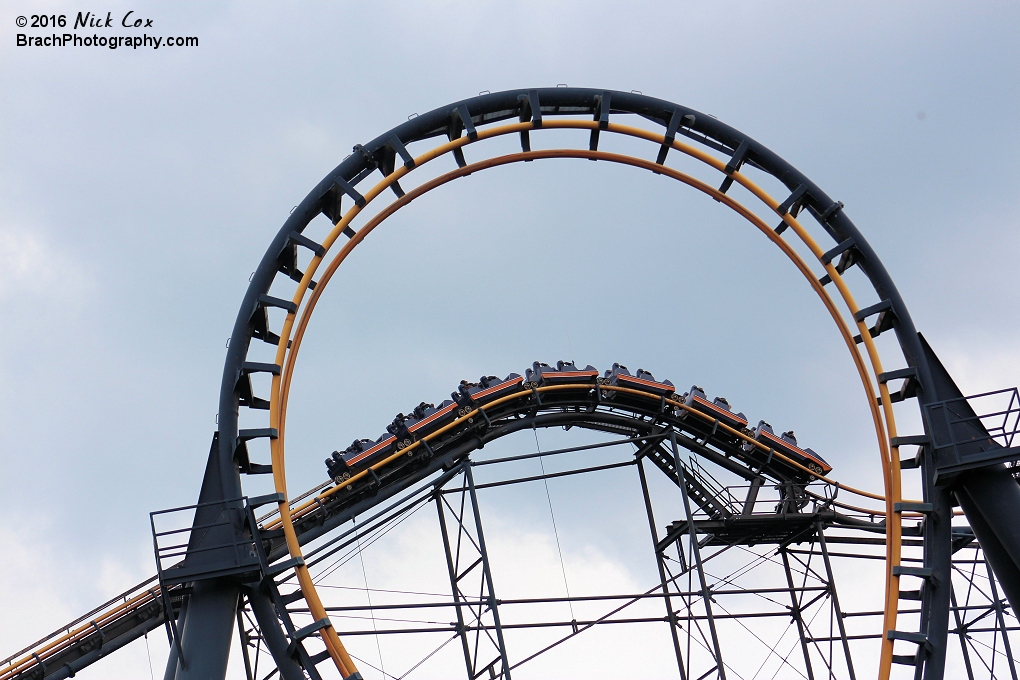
[{"xmin": 0, "ymin": 87, "xmax": 1020, "ymax": 680}]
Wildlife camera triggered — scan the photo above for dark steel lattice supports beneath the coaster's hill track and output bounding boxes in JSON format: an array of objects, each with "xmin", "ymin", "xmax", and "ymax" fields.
[{"xmin": 231, "ymin": 426, "xmax": 1020, "ymax": 680}]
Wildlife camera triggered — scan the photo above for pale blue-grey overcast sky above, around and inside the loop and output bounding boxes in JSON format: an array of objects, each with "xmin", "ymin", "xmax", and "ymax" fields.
[{"xmin": 0, "ymin": 0, "xmax": 1020, "ymax": 678}]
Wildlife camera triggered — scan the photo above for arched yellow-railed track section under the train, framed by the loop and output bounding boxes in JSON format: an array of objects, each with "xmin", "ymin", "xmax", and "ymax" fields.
[{"xmin": 275, "ymin": 381, "xmax": 883, "ymax": 542}]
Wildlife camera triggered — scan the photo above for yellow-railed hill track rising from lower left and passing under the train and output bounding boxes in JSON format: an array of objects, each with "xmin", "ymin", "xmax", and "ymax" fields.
[{"xmin": 0, "ymin": 382, "xmax": 860, "ymax": 680}]
